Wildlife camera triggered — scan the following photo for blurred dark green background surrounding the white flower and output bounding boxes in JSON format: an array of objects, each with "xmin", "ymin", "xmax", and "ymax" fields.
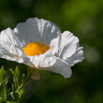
[{"xmin": 0, "ymin": 0, "xmax": 103, "ymax": 103}]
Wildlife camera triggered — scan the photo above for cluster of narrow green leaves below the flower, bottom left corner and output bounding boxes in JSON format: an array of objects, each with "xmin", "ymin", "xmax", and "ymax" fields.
[{"xmin": 0, "ymin": 67, "xmax": 25, "ymax": 103}]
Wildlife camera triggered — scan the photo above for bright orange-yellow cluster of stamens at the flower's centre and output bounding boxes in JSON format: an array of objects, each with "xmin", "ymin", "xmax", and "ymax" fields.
[{"xmin": 24, "ymin": 41, "xmax": 50, "ymax": 56}]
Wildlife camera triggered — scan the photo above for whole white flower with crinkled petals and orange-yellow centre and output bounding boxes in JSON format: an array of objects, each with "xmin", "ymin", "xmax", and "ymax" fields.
[{"xmin": 0, "ymin": 18, "xmax": 83, "ymax": 78}]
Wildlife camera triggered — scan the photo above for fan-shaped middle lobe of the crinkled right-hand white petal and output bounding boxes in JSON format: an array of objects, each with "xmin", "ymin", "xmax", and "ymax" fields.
[{"xmin": 58, "ymin": 31, "xmax": 79, "ymax": 59}]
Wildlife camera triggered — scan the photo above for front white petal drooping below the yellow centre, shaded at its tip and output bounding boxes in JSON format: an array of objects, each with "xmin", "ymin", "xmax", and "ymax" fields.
[{"xmin": 28, "ymin": 51, "xmax": 72, "ymax": 78}]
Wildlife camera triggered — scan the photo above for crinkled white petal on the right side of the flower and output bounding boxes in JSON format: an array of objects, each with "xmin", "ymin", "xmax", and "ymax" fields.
[{"xmin": 50, "ymin": 31, "xmax": 83, "ymax": 66}]
